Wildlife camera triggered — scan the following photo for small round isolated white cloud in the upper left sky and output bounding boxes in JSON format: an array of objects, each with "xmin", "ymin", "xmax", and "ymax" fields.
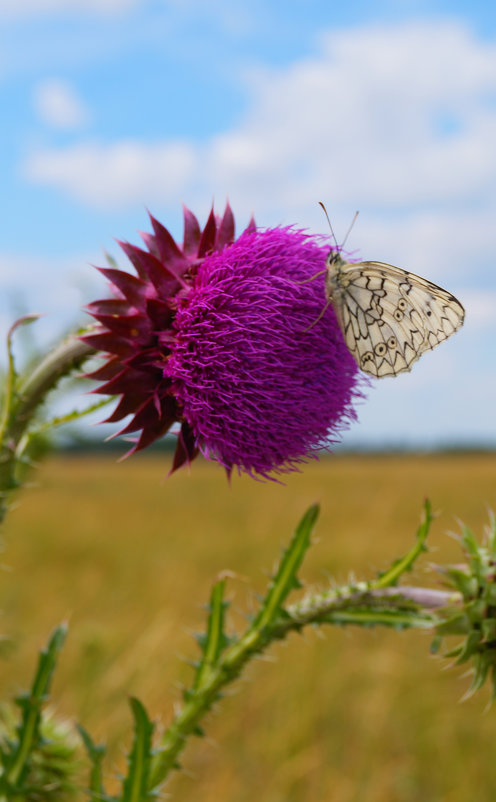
[{"xmin": 33, "ymin": 79, "xmax": 89, "ymax": 129}]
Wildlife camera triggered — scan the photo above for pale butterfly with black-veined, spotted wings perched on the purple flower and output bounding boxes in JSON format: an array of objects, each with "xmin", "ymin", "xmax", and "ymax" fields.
[{"xmin": 326, "ymin": 252, "xmax": 465, "ymax": 378}]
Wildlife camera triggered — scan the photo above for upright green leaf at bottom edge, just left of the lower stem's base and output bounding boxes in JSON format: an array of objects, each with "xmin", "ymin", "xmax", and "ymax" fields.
[{"xmin": 121, "ymin": 698, "xmax": 156, "ymax": 802}]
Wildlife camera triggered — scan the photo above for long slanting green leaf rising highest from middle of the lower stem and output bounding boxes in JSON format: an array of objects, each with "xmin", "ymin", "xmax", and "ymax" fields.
[{"xmin": 252, "ymin": 504, "xmax": 319, "ymax": 630}]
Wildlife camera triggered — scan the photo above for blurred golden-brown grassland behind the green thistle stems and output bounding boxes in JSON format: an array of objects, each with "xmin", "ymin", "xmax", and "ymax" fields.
[{"xmin": 0, "ymin": 454, "xmax": 496, "ymax": 802}]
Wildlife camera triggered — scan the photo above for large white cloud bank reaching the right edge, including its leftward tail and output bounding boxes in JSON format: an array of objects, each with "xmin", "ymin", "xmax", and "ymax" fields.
[{"xmin": 23, "ymin": 20, "xmax": 496, "ymax": 219}]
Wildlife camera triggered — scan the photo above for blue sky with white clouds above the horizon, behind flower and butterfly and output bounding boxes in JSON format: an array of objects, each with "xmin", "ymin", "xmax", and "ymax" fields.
[{"xmin": 0, "ymin": 0, "xmax": 496, "ymax": 448}]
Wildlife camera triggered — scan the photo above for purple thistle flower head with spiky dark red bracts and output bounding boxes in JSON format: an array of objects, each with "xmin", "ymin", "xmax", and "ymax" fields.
[{"xmin": 84, "ymin": 205, "xmax": 360, "ymax": 478}]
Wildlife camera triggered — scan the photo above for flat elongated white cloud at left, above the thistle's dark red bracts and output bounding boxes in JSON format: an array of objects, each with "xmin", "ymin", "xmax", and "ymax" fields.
[{"xmin": 24, "ymin": 139, "xmax": 196, "ymax": 209}]
